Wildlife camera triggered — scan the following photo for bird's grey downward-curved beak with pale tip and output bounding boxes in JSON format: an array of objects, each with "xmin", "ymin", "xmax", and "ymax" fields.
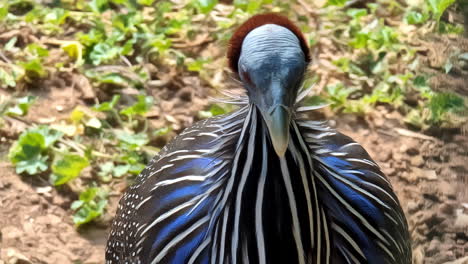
[{"xmin": 260, "ymin": 105, "xmax": 291, "ymax": 157}]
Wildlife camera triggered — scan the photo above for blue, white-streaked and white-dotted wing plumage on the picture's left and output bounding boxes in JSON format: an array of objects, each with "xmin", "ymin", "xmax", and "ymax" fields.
[{"xmin": 106, "ymin": 106, "xmax": 245, "ymax": 264}]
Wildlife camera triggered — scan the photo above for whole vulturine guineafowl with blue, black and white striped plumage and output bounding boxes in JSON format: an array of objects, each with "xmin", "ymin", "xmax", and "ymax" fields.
[{"xmin": 106, "ymin": 13, "xmax": 412, "ymax": 264}]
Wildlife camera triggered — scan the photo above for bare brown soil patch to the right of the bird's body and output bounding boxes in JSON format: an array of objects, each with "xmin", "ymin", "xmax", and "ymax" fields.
[{"xmin": 336, "ymin": 109, "xmax": 468, "ymax": 264}]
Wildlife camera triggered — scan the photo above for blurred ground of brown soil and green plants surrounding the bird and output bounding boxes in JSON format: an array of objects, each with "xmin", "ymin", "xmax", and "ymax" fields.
[{"xmin": 0, "ymin": 0, "xmax": 468, "ymax": 264}]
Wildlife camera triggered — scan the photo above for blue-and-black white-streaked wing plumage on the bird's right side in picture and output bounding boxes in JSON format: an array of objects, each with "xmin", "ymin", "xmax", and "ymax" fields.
[{"xmin": 299, "ymin": 121, "xmax": 411, "ymax": 264}]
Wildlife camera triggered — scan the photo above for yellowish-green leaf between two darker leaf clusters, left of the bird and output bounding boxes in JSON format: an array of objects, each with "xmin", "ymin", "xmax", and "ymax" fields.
[{"xmin": 51, "ymin": 154, "xmax": 89, "ymax": 185}]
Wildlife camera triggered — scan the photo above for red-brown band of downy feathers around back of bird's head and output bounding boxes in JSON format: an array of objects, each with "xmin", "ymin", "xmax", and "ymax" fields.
[{"xmin": 227, "ymin": 13, "xmax": 310, "ymax": 72}]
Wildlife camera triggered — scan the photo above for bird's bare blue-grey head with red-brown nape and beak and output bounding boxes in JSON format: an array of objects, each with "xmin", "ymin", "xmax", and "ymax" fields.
[{"xmin": 228, "ymin": 14, "xmax": 310, "ymax": 157}]
